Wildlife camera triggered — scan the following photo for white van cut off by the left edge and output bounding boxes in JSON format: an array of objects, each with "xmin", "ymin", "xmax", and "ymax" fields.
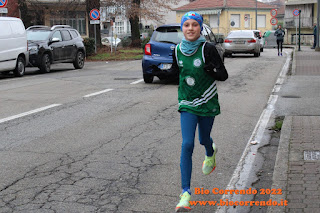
[{"xmin": 0, "ymin": 17, "xmax": 29, "ymax": 76}]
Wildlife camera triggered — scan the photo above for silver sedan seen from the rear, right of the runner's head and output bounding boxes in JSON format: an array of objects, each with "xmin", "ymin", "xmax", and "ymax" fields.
[{"xmin": 223, "ymin": 30, "xmax": 260, "ymax": 57}]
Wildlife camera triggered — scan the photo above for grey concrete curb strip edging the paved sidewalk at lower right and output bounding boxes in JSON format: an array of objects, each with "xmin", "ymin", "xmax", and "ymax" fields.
[{"xmin": 267, "ymin": 116, "xmax": 292, "ymax": 213}]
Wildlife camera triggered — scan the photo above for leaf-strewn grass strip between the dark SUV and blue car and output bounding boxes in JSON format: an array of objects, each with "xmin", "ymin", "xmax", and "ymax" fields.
[{"xmin": 87, "ymin": 47, "xmax": 143, "ymax": 61}]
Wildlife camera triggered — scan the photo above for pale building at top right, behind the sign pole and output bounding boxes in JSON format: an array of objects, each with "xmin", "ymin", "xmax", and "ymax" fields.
[{"xmin": 284, "ymin": 0, "xmax": 317, "ymax": 45}]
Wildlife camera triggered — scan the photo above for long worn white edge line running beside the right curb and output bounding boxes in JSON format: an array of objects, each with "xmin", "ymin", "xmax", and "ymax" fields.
[{"xmin": 216, "ymin": 50, "xmax": 291, "ymax": 213}]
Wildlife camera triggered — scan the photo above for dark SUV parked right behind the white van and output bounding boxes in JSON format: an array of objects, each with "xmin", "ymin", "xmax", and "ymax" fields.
[{"xmin": 27, "ymin": 25, "xmax": 86, "ymax": 73}]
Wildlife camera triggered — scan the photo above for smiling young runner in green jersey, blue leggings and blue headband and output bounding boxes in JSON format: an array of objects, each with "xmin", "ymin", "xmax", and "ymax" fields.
[{"xmin": 172, "ymin": 11, "xmax": 228, "ymax": 212}]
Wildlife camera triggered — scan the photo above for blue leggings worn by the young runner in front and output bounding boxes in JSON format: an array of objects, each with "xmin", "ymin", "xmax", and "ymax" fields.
[{"xmin": 180, "ymin": 112, "xmax": 215, "ymax": 189}]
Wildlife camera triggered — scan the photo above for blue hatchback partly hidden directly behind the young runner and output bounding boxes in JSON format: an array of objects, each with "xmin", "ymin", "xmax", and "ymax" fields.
[{"xmin": 142, "ymin": 24, "xmax": 224, "ymax": 83}]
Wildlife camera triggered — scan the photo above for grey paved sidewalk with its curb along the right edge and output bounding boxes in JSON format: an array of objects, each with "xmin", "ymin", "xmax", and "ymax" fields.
[{"xmin": 268, "ymin": 47, "xmax": 320, "ymax": 213}]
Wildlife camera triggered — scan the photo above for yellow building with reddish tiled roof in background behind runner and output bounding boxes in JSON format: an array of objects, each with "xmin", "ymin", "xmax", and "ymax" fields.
[{"xmin": 174, "ymin": 0, "xmax": 274, "ymax": 36}]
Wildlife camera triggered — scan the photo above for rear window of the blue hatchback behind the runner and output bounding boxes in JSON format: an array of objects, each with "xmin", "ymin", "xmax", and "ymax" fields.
[{"xmin": 151, "ymin": 27, "xmax": 183, "ymax": 44}]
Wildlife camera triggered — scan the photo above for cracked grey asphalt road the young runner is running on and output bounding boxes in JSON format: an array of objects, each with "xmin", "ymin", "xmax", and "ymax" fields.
[{"xmin": 0, "ymin": 49, "xmax": 291, "ymax": 213}]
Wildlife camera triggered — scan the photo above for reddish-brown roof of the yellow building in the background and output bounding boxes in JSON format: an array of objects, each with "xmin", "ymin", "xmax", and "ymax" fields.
[{"xmin": 174, "ymin": 0, "xmax": 274, "ymax": 11}]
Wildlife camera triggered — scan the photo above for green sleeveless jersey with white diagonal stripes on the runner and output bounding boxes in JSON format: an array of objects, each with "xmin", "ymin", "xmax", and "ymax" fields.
[{"xmin": 175, "ymin": 43, "xmax": 220, "ymax": 116}]
